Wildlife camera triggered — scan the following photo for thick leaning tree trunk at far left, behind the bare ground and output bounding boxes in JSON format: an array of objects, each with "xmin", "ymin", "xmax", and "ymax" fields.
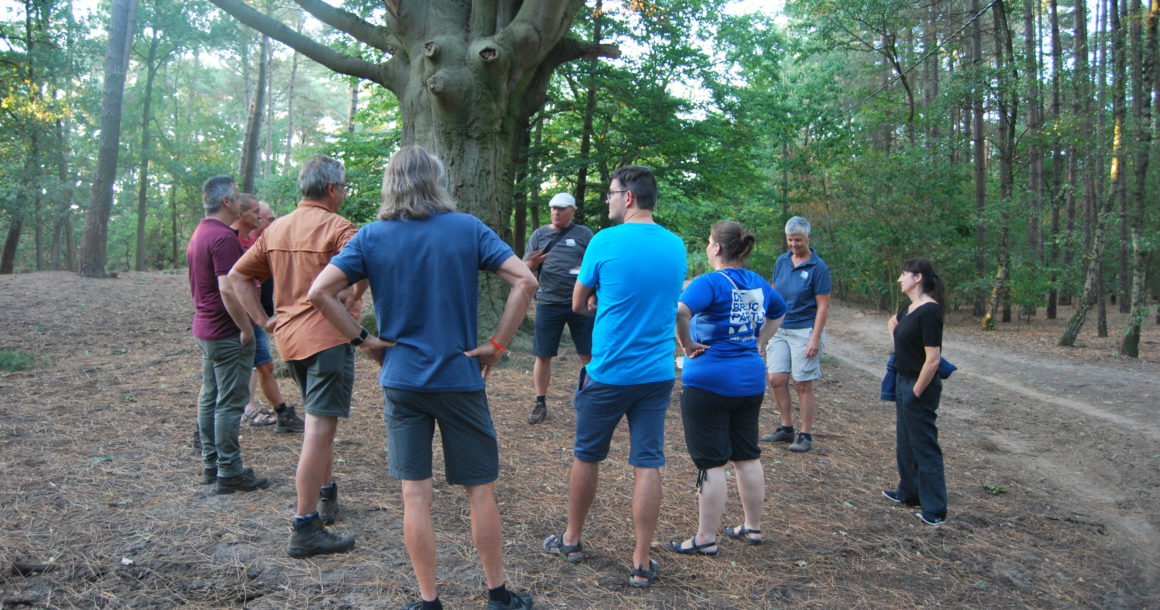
[{"xmin": 80, "ymin": 0, "xmax": 137, "ymax": 277}]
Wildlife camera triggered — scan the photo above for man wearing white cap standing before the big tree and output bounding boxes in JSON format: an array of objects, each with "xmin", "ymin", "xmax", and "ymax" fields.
[{"xmin": 523, "ymin": 193, "xmax": 593, "ymax": 423}]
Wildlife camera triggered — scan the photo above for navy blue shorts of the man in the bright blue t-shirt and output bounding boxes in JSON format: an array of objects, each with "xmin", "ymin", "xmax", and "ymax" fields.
[{"xmin": 572, "ymin": 369, "xmax": 676, "ymax": 469}]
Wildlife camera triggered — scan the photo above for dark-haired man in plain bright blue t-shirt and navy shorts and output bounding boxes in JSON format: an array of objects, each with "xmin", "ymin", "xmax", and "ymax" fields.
[{"xmin": 544, "ymin": 166, "xmax": 686, "ymax": 587}]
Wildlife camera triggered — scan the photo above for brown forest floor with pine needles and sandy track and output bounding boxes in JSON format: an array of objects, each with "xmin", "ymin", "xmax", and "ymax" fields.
[{"xmin": 0, "ymin": 273, "xmax": 1160, "ymax": 609}]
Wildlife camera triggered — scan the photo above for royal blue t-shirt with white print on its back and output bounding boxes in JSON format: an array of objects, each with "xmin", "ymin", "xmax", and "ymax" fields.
[{"xmin": 681, "ymin": 269, "xmax": 785, "ymax": 397}]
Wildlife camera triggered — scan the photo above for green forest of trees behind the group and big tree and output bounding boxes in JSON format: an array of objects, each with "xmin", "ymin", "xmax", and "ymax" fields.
[{"xmin": 0, "ymin": 0, "xmax": 1160, "ymax": 355}]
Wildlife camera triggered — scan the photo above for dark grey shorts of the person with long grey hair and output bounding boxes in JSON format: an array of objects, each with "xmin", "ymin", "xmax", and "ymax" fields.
[{"xmin": 383, "ymin": 387, "xmax": 500, "ymax": 485}]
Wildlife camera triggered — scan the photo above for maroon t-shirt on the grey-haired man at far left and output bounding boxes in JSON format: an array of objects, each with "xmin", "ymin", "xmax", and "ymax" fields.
[{"xmin": 186, "ymin": 218, "xmax": 241, "ymax": 341}]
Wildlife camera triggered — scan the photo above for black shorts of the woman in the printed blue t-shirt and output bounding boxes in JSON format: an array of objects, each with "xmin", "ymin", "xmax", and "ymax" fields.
[{"xmin": 681, "ymin": 386, "xmax": 764, "ymax": 470}]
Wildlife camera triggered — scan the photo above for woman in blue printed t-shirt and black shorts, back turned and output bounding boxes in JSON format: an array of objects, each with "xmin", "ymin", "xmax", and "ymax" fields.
[{"xmin": 668, "ymin": 222, "xmax": 785, "ymax": 555}]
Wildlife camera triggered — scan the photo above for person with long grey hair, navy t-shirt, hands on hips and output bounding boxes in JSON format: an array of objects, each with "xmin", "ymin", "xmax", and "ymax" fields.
[{"xmin": 310, "ymin": 146, "xmax": 536, "ymax": 610}]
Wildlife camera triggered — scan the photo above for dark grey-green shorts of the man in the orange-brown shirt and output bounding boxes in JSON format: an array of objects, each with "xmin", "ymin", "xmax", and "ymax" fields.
[{"xmin": 287, "ymin": 343, "xmax": 355, "ymax": 417}]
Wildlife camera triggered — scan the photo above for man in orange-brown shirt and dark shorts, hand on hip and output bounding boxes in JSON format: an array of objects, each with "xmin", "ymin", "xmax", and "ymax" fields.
[{"xmin": 230, "ymin": 155, "xmax": 365, "ymax": 558}]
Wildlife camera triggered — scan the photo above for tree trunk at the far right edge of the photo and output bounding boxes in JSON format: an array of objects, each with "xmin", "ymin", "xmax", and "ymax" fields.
[{"xmin": 1119, "ymin": 0, "xmax": 1160, "ymax": 358}]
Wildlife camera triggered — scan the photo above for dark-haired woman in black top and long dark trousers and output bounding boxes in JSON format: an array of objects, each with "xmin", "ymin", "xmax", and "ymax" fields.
[{"xmin": 882, "ymin": 259, "xmax": 947, "ymax": 525}]
